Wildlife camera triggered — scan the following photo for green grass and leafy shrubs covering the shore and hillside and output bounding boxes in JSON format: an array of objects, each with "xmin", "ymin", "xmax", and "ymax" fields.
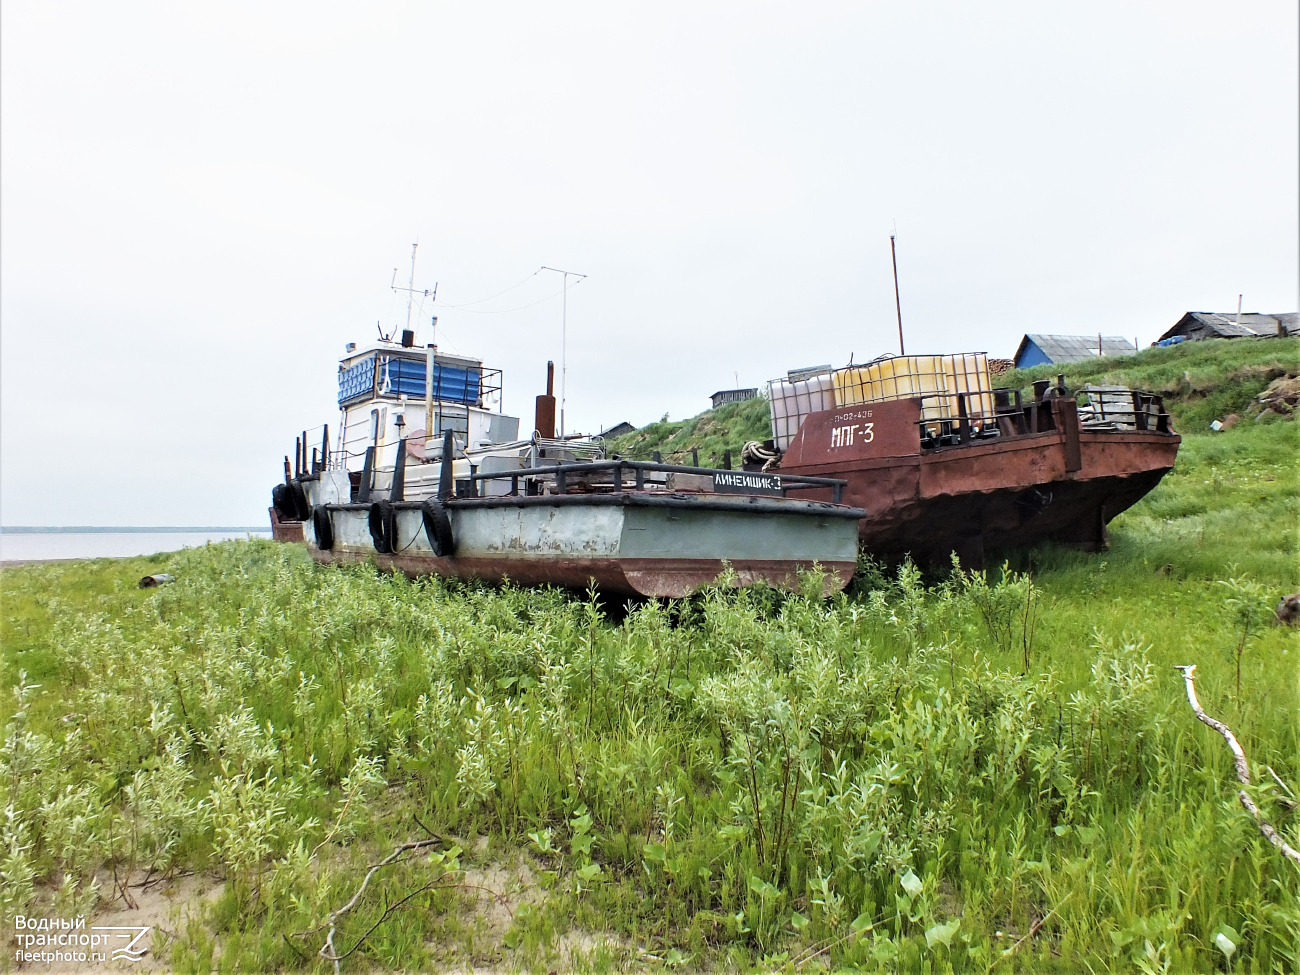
[{"xmin": 0, "ymin": 343, "xmax": 1300, "ymax": 975}]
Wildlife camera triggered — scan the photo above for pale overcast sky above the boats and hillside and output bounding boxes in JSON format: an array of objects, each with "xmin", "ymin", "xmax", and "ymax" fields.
[{"xmin": 0, "ymin": 0, "xmax": 1300, "ymax": 525}]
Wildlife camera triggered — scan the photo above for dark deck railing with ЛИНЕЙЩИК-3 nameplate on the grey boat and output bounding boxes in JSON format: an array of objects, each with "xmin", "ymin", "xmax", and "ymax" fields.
[{"xmin": 460, "ymin": 460, "xmax": 848, "ymax": 504}]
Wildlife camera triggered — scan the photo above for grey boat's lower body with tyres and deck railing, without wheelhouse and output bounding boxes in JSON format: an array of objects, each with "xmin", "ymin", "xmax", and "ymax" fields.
[{"xmin": 291, "ymin": 462, "xmax": 863, "ymax": 597}]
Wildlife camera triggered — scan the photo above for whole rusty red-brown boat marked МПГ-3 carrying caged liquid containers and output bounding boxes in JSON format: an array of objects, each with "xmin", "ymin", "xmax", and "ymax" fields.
[{"xmin": 751, "ymin": 352, "xmax": 1182, "ymax": 566}]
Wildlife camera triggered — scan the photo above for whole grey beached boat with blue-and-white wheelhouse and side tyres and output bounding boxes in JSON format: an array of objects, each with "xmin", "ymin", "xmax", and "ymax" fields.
[{"xmin": 270, "ymin": 286, "xmax": 866, "ymax": 597}]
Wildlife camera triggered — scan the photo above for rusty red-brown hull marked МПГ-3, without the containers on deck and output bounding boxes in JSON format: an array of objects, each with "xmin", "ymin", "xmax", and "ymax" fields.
[{"xmin": 780, "ymin": 400, "xmax": 1180, "ymax": 564}]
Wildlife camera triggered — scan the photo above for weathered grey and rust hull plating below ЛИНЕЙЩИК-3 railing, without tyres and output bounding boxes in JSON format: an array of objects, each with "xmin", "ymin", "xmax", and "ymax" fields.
[{"xmin": 297, "ymin": 494, "xmax": 861, "ymax": 598}]
